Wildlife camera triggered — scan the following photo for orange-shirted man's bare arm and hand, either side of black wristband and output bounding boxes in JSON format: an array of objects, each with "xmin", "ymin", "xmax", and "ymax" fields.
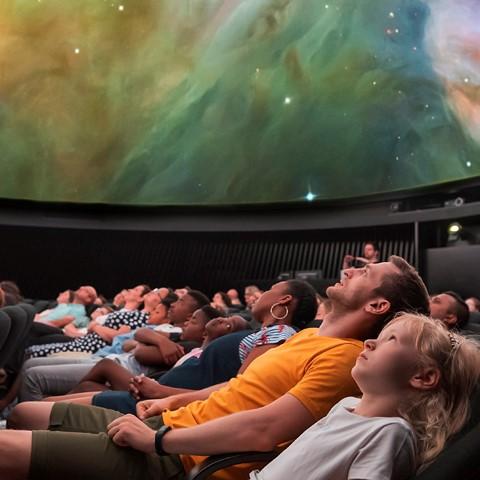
[{"xmin": 107, "ymin": 393, "xmax": 315, "ymax": 455}]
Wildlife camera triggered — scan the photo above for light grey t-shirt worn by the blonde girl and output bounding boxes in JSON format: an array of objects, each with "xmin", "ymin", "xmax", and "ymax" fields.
[{"xmin": 250, "ymin": 397, "xmax": 416, "ymax": 480}]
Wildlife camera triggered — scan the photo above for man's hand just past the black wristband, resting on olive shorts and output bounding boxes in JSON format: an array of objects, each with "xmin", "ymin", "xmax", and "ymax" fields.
[{"xmin": 107, "ymin": 415, "xmax": 155, "ymax": 453}]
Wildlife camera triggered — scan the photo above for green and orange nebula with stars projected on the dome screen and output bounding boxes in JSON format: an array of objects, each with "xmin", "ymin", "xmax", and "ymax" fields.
[{"xmin": 0, "ymin": 0, "xmax": 480, "ymax": 205}]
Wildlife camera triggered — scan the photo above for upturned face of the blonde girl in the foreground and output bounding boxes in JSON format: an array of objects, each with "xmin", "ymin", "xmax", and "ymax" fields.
[{"xmin": 352, "ymin": 320, "xmax": 419, "ymax": 395}]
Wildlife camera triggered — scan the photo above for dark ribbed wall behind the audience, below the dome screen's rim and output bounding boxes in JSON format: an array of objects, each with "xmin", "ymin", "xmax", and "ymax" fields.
[{"xmin": 0, "ymin": 224, "xmax": 414, "ymax": 298}]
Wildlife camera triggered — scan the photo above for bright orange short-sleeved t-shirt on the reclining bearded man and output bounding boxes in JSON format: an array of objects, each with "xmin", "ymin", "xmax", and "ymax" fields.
[{"xmin": 162, "ymin": 328, "xmax": 363, "ymax": 479}]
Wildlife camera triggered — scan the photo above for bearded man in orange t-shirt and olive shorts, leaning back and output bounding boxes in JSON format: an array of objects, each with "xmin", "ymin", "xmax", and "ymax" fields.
[{"xmin": 0, "ymin": 257, "xmax": 428, "ymax": 480}]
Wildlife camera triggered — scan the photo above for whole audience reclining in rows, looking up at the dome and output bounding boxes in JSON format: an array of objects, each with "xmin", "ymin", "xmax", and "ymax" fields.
[{"xmin": 0, "ymin": 256, "xmax": 480, "ymax": 480}]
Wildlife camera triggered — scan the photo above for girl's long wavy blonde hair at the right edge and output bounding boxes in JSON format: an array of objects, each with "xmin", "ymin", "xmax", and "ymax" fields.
[{"xmin": 388, "ymin": 313, "xmax": 480, "ymax": 468}]
